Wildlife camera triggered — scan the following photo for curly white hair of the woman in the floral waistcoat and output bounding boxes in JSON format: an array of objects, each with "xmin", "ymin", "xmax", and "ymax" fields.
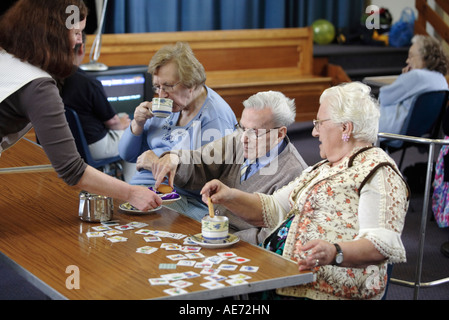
[{"xmin": 320, "ymin": 82, "xmax": 380, "ymax": 143}]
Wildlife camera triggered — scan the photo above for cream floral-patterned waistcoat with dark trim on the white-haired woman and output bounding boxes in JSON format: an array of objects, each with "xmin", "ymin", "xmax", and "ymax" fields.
[{"xmin": 277, "ymin": 147, "xmax": 401, "ymax": 299}]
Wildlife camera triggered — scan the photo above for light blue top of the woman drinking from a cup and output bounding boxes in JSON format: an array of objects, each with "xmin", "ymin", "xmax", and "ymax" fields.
[{"xmin": 119, "ymin": 87, "xmax": 237, "ymax": 186}]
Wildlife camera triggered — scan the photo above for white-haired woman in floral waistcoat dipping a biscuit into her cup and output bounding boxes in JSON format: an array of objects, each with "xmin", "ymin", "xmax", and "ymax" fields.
[{"xmin": 202, "ymin": 82, "xmax": 409, "ymax": 299}]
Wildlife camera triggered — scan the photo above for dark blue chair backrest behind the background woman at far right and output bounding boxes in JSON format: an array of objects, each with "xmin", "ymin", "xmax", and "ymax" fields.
[{"xmin": 405, "ymin": 90, "xmax": 449, "ymax": 139}]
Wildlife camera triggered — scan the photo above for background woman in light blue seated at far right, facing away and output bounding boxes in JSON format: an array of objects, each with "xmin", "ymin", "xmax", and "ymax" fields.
[{"xmin": 379, "ymin": 35, "xmax": 449, "ymax": 145}]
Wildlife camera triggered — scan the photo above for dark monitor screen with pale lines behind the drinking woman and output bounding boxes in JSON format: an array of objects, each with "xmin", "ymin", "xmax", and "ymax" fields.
[{"xmin": 87, "ymin": 66, "xmax": 153, "ymax": 118}]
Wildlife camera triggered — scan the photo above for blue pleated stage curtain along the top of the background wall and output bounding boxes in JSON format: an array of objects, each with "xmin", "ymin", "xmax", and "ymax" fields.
[{"xmin": 105, "ymin": 0, "xmax": 365, "ymax": 33}]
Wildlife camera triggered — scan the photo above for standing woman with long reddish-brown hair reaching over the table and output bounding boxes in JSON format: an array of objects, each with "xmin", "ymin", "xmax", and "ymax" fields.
[{"xmin": 0, "ymin": 0, "xmax": 161, "ymax": 214}]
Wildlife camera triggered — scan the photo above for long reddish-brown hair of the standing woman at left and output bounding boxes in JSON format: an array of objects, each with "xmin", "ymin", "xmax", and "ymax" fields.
[{"xmin": 0, "ymin": 0, "xmax": 88, "ymax": 78}]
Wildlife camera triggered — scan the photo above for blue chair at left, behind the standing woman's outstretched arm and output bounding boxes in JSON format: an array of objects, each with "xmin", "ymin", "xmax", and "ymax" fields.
[{"xmin": 65, "ymin": 106, "xmax": 122, "ymax": 177}]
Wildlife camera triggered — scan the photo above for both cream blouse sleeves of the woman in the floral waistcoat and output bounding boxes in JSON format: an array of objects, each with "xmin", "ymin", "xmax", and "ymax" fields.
[{"xmin": 258, "ymin": 166, "xmax": 408, "ymax": 263}]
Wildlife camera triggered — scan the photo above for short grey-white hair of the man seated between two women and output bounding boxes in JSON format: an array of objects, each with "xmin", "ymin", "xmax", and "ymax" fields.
[{"xmin": 243, "ymin": 91, "xmax": 296, "ymax": 127}]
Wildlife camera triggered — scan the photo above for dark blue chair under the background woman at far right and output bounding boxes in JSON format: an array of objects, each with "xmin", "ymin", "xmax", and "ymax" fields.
[{"xmin": 380, "ymin": 90, "xmax": 449, "ymax": 169}]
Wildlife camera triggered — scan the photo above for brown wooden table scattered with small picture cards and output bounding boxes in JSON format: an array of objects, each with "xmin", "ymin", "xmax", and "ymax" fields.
[{"xmin": 0, "ymin": 140, "xmax": 313, "ymax": 300}]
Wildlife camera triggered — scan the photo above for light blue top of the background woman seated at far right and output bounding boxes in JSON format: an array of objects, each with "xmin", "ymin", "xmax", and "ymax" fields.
[{"xmin": 379, "ymin": 69, "xmax": 448, "ymax": 143}]
